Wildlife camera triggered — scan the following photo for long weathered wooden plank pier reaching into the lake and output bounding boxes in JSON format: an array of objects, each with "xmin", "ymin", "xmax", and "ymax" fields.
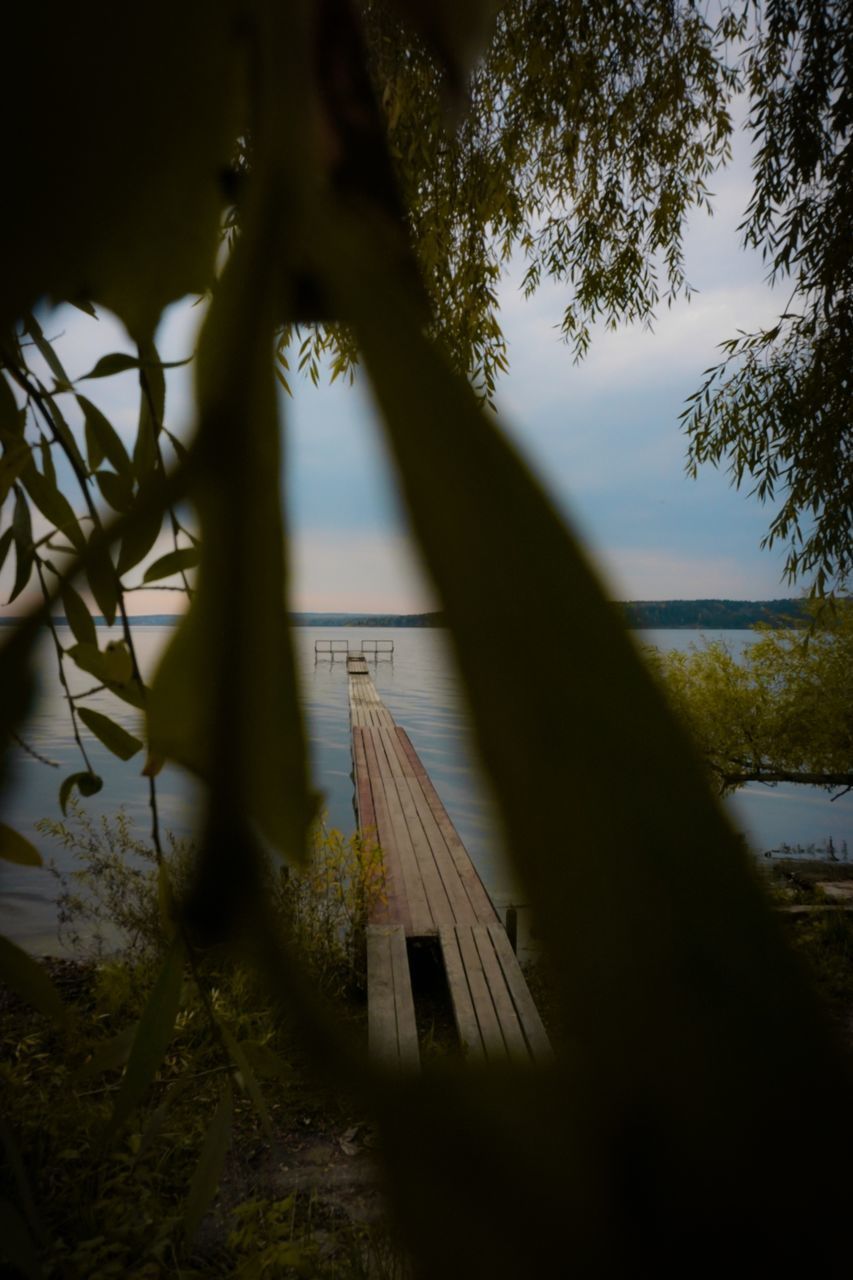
[{"xmin": 347, "ymin": 655, "xmax": 552, "ymax": 1070}]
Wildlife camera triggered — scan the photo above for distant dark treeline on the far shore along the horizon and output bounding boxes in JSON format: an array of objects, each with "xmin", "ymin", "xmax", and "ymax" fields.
[{"xmin": 6, "ymin": 599, "xmax": 806, "ymax": 631}]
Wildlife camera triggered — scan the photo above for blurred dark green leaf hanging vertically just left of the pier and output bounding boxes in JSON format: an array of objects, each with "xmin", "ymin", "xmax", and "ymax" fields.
[{"xmin": 149, "ymin": 217, "xmax": 313, "ymax": 880}]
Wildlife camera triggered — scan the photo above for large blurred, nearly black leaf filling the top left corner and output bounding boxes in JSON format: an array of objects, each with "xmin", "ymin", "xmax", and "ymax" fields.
[{"xmin": 3, "ymin": 0, "xmax": 245, "ymax": 337}]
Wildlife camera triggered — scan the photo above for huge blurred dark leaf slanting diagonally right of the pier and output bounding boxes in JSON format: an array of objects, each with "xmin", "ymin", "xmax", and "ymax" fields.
[{"xmin": 329, "ymin": 215, "xmax": 845, "ymax": 1254}]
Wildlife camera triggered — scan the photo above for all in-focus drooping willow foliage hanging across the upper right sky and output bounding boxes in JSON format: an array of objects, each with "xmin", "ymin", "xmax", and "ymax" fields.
[{"xmin": 292, "ymin": 0, "xmax": 853, "ymax": 594}]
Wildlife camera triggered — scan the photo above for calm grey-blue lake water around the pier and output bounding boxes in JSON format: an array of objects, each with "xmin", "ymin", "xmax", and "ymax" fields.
[{"xmin": 0, "ymin": 625, "xmax": 853, "ymax": 952}]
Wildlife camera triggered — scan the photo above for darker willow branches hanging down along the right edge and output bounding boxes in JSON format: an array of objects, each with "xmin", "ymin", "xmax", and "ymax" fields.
[{"xmin": 685, "ymin": 0, "xmax": 853, "ymax": 594}]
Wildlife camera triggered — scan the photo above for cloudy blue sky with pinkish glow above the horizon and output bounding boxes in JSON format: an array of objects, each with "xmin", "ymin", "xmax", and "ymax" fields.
[{"xmin": 0, "ymin": 102, "xmax": 797, "ymax": 613}]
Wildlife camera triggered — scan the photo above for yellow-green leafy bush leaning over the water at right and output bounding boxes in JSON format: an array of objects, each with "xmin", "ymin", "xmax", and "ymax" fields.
[{"xmin": 653, "ymin": 602, "xmax": 853, "ymax": 791}]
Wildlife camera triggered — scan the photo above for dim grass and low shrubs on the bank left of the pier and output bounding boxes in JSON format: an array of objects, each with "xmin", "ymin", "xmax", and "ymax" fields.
[{"xmin": 0, "ymin": 809, "xmax": 405, "ymax": 1280}]
